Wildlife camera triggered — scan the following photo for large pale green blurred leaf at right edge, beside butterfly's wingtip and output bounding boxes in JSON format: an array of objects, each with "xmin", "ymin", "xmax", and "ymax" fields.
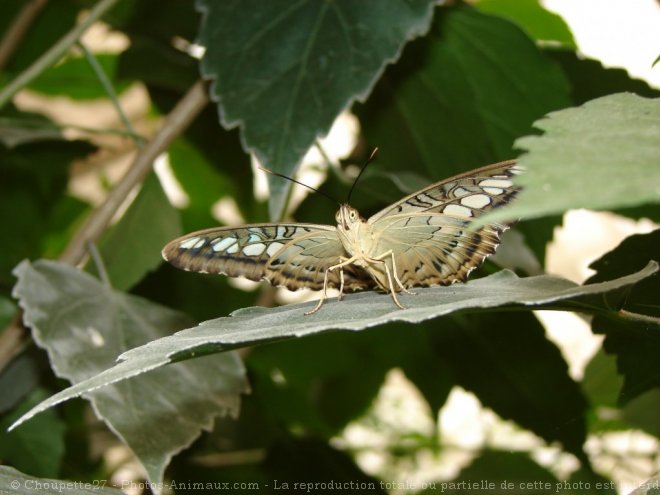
[{"xmin": 479, "ymin": 93, "xmax": 660, "ymax": 222}]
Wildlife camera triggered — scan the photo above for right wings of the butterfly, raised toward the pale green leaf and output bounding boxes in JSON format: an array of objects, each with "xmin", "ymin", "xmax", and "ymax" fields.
[{"xmin": 368, "ymin": 161, "xmax": 520, "ymax": 287}]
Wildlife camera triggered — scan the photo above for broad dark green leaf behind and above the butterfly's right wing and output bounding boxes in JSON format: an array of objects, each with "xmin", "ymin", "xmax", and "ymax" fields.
[{"xmin": 356, "ymin": 8, "xmax": 570, "ymax": 180}]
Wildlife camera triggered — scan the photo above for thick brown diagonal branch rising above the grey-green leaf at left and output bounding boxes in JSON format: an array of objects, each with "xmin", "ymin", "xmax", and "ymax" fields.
[{"xmin": 60, "ymin": 81, "xmax": 209, "ymax": 265}]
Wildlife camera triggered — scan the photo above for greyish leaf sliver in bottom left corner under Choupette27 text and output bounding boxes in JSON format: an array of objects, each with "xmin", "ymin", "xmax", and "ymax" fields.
[{"xmin": 0, "ymin": 466, "xmax": 124, "ymax": 495}]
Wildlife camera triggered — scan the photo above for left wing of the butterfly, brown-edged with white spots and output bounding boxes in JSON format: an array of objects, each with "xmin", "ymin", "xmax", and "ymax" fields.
[{"xmin": 163, "ymin": 223, "xmax": 373, "ymax": 290}]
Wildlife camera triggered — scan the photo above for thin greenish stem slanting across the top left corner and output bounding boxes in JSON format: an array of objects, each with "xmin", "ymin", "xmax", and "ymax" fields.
[{"xmin": 0, "ymin": 0, "xmax": 119, "ymax": 108}]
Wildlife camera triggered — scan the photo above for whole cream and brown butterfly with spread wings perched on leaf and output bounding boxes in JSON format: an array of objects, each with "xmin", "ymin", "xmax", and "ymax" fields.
[{"xmin": 162, "ymin": 160, "xmax": 521, "ymax": 314}]
